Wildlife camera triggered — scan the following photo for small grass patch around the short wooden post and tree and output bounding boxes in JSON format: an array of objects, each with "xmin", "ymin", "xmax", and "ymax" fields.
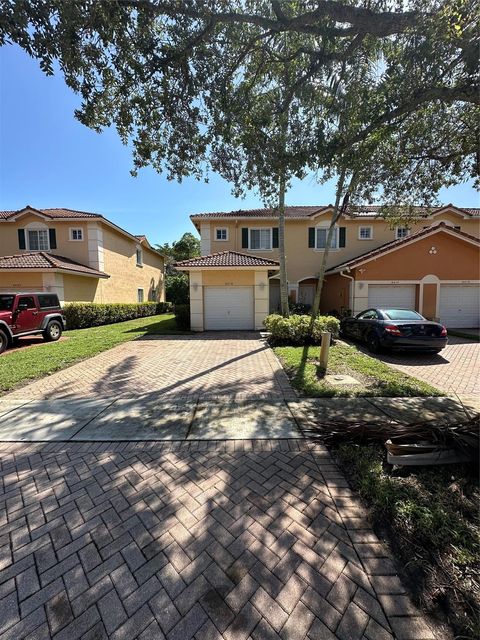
[{"xmin": 274, "ymin": 342, "xmax": 444, "ymax": 397}]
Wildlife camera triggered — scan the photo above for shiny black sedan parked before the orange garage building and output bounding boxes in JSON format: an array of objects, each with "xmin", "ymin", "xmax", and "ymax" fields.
[{"xmin": 340, "ymin": 309, "xmax": 447, "ymax": 353}]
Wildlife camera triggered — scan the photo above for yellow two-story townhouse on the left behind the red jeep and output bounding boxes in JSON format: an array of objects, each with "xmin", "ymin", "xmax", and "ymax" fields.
[{"xmin": 0, "ymin": 206, "xmax": 165, "ymax": 303}]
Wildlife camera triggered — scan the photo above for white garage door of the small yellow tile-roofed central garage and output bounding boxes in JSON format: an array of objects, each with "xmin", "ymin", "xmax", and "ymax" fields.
[{"xmin": 203, "ymin": 287, "xmax": 255, "ymax": 331}]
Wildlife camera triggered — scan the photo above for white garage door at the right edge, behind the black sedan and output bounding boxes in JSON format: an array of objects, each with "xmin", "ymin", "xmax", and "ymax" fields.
[{"xmin": 439, "ymin": 284, "xmax": 480, "ymax": 329}]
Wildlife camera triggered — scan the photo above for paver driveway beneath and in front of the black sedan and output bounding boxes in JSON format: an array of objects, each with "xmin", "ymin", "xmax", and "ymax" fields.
[{"xmin": 366, "ymin": 336, "xmax": 480, "ymax": 395}]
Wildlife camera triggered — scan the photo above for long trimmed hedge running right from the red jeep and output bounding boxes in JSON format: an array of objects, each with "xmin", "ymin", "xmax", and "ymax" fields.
[{"xmin": 63, "ymin": 302, "xmax": 172, "ymax": 329}]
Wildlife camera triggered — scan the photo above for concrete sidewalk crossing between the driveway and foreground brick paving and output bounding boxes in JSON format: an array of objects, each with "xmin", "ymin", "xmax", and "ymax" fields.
[{"xmin": 0, "ymin": 393, "xmax": 474, "ymax": 442}]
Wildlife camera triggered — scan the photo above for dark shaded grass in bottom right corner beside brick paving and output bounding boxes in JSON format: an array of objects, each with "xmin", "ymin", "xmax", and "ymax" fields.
[{"xmin": 333, "ymin": 444, "xmax": 480, "ymax": 638}]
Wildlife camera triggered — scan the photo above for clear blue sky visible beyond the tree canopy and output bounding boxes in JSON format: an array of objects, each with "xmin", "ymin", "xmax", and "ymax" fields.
[{"xmin": 0, "ymin": 45, "xmax": 479, "ymax": 243}]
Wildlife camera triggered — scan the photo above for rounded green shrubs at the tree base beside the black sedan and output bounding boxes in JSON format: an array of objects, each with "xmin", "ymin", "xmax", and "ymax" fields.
[{"xmin": 263, "ymin": 314, "xmax": 340, "ymax": 345}]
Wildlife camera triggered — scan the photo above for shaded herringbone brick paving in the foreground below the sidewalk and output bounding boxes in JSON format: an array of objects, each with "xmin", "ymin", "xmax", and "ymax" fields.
[{"xmin": 0, "ymin": 440, "xmax": 433, "ymax": 640}]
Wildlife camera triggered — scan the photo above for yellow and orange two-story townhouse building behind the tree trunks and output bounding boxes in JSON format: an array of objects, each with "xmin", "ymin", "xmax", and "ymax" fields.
[{"xmin": 179, "ymin": 205, "xmax": 480, "ymax": 330}]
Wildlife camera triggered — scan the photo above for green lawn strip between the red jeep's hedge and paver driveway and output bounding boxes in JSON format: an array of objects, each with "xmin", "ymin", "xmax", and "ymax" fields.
[{"xmin": 0, "ymin": 313, "xmax": 189, "ymax": 393}]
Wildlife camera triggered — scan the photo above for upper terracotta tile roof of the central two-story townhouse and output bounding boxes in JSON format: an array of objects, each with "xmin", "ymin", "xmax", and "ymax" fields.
[{"xmin": 190, "ymin": 204, "xmax": 480, "ymax": 222}]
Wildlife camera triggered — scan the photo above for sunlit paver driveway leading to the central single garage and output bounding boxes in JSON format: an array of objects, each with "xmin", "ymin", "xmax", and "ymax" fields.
[{"xmin": 8, "ymin": 332, "xmax": 293, "ymax": 400}]
